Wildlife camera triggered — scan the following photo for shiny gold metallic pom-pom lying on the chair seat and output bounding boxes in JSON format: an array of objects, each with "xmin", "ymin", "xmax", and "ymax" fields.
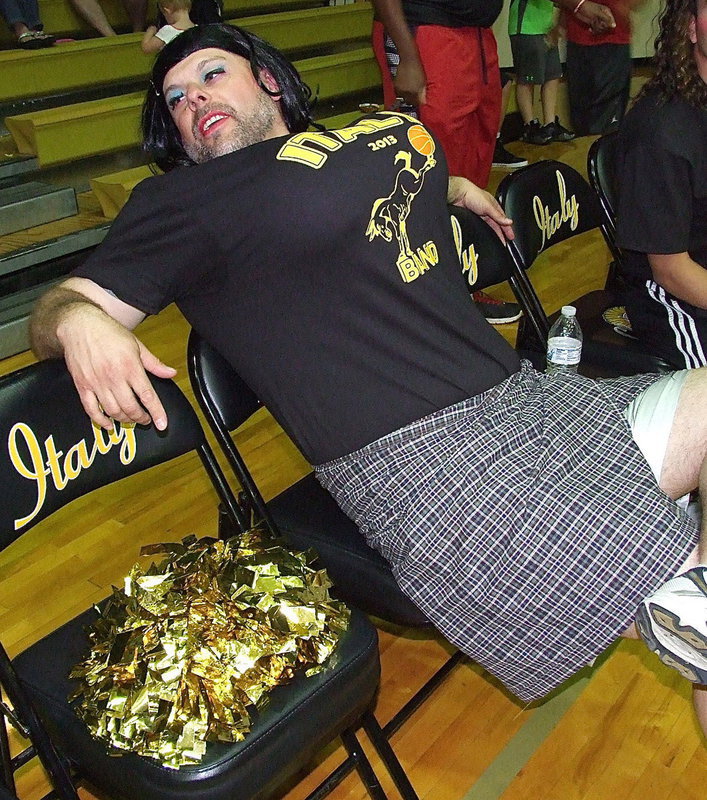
[{"xmin": 71, "ymin": 528, "xmax": 349, "ymax": 769}]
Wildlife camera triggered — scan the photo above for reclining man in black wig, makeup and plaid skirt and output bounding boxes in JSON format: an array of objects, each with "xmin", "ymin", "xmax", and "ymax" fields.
[{"xmin": 32, "ymin": 20, "xmax": 707, "ymax": 727}]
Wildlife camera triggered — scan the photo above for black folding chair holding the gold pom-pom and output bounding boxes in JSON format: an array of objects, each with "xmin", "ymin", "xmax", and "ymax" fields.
[{"xmin": 0, "ymin": 361, "xmax": 416, "ymax": 800}]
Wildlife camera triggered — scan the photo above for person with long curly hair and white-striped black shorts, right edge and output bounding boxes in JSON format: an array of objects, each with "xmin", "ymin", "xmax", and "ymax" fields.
[{"xmin": 616, "ymin": 0, "xmax": 707, "ymax": 368}]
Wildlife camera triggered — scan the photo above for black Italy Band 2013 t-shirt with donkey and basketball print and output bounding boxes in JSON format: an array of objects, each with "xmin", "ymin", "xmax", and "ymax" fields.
[{"xmin": 74, "ymin": 113, "xmax": 519, "ymax": 464}]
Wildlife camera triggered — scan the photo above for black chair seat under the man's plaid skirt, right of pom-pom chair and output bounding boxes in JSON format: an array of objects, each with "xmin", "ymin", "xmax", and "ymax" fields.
[{"xmin": 268, "ymin": 474, "xmax": 430, "ymax": 627}]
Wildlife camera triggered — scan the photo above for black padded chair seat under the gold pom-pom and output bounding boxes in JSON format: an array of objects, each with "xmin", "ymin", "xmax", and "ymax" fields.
[{"xmin": 13, "ymin": 610, "xmax": 380, "ymax": 800}]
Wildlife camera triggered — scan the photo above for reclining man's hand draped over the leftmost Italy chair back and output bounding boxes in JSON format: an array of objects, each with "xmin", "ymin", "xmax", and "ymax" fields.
[{"xmin": 57, "ymin": 305, "xmax": 176, "ymax": 430}]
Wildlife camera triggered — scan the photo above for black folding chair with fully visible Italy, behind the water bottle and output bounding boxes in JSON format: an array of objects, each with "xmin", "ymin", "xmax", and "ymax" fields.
[{"xmin": 497, "ymin": 161, "xmax": 673, "ymax": 377}]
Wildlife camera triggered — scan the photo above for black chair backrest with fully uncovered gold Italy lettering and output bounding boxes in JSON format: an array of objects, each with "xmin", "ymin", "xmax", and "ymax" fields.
[{"xmin": 497, "ymin": 161, "xmax": 601, "ymax": 270}]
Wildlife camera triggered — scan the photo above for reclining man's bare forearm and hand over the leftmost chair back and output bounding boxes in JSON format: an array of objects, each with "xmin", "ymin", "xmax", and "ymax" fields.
[{"xmin": 30, "ymin": 278, "xmax": 176, "ymax": 430}]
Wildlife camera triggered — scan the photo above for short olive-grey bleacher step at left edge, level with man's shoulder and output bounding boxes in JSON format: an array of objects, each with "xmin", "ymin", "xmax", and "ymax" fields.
[{"xmin": 0, "ymin": 181, "xmax": 78, "ymax": 236}]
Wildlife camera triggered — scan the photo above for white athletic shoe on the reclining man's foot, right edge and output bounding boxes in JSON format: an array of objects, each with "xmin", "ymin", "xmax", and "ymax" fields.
[{"xmin": 636, "ymin": 566, "xmax": 707, "ymax": 684}]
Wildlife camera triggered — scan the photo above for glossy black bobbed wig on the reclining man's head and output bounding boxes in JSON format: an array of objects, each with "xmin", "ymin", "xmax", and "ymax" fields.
[{"xmin": 142, "ymin": 24, "xmax": 312, "ymax": 172}]
